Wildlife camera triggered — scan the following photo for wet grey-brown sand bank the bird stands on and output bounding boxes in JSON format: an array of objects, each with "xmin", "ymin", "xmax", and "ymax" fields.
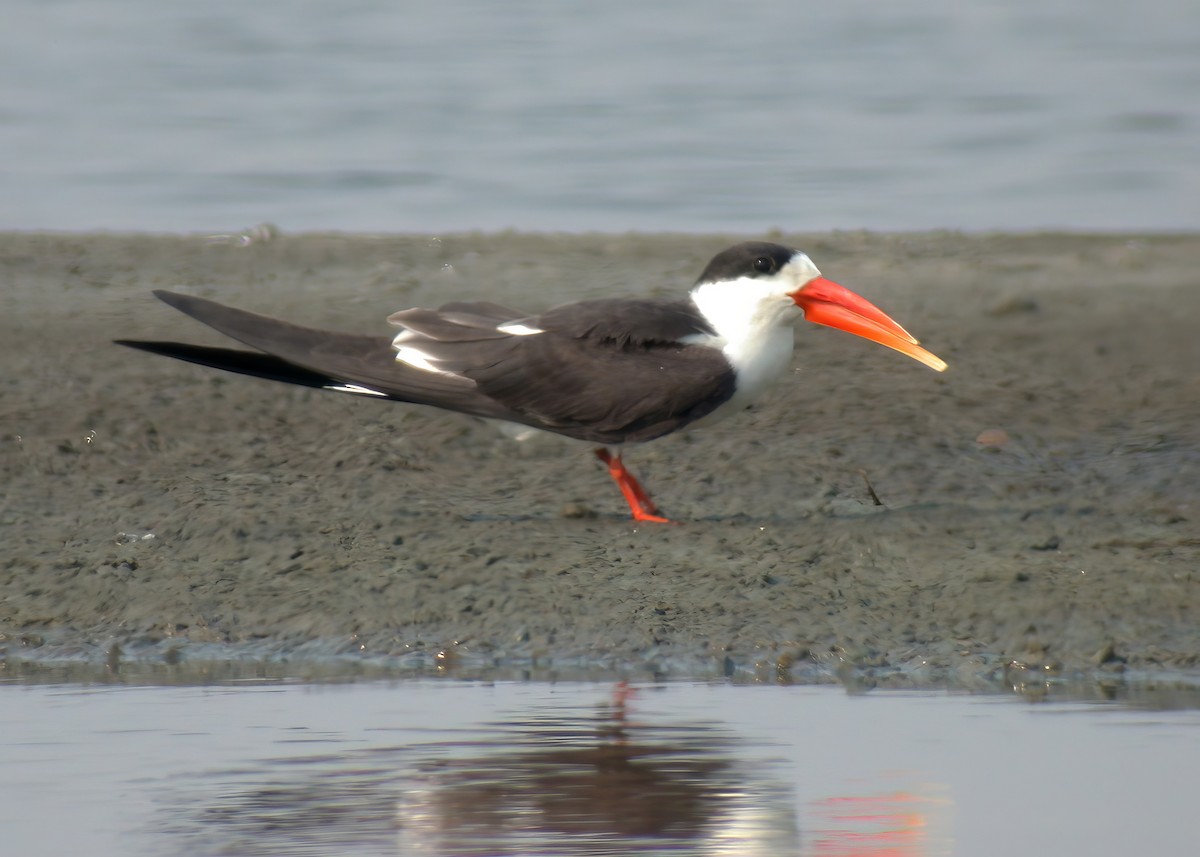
[{"xmin": 0, "ymin": 233, "xmax": 1200, "ymax": 679}]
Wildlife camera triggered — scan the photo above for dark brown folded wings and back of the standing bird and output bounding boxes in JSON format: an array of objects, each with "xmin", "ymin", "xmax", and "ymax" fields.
[{"xmin": 121, "ymin": 290, "xmax": 734, "ymax": 444}]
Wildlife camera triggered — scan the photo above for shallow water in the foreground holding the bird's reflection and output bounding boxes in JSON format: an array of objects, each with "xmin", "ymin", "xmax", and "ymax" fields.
[{"xmin": 0, "ymin": 679, "xmax": 1200, "ymax": 857}]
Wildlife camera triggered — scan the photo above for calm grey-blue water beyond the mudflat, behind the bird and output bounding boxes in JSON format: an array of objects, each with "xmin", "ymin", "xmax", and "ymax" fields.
[{"xmin": 0, "ymin": 0, "xmax": 1200, "ymax": 233}]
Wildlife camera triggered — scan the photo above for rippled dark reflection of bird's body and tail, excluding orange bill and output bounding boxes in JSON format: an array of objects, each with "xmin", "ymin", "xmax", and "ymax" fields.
[{"xmin": 159, "ymin": 691, "xmax": 799, "ymax": 857}]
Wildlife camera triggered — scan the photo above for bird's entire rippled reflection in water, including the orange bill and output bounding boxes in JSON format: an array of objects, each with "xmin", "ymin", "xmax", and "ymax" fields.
[{"xmin": 171, "ymin": 685, "xmax": 952, "ymax": 857}]
